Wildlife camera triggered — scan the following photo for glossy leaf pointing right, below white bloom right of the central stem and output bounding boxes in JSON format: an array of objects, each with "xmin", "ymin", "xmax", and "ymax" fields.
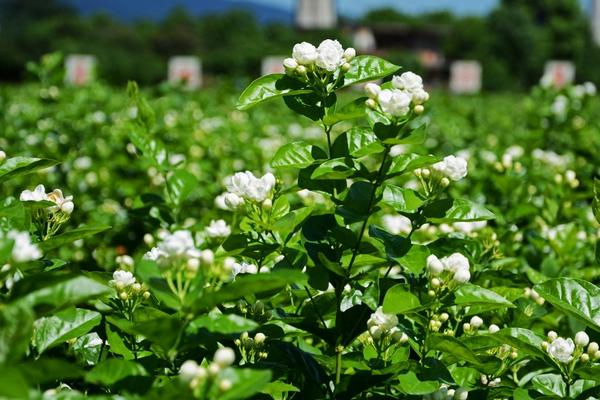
[{"xmin": 423, "ymin": 199, "xmax": 496, "ymax": 223}]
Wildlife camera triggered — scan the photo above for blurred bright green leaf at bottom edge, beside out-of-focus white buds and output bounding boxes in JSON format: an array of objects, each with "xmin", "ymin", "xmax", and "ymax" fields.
[{"xmin": 209, "ymin": 368, "xmax": 271, "ymax": 400}]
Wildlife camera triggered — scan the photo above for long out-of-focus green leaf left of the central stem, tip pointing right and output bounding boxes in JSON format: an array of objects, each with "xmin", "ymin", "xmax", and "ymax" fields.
[{"xmin": 192, "ymin": 269, "xmax": 306, "ymax": 309}]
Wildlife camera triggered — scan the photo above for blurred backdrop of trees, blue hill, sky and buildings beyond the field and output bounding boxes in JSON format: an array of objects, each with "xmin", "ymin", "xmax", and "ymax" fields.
[{"xmin": 0, "ymin": 0, "xmax": 600, "ymax": 91}]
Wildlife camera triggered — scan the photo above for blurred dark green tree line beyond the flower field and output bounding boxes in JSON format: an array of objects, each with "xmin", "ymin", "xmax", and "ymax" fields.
[{"xmin": 0, "ymin": 0, "xmax": 600, "ymax": 90}]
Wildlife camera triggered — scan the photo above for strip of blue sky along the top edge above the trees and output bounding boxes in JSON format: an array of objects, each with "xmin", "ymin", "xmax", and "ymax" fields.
[{"xmin": 254, "ymin": 0, "xmax": 499, "ymax": 17}]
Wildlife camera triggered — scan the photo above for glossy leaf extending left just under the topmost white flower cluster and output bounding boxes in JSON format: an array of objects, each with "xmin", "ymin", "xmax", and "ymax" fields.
[{"xmin": 237, "ymin": 74, "xmax": 311, "ymax": 110}]
